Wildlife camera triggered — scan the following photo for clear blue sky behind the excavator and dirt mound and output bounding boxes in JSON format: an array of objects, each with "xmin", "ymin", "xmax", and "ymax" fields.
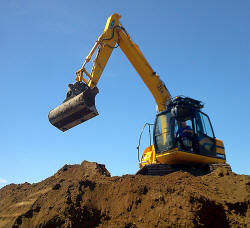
[{"xmin": 0, "ymin": 0, "xmax": 250, "ymax": 187}]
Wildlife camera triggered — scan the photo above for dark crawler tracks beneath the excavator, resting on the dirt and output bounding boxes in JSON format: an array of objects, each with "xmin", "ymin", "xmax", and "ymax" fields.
[{"xmin": 136, "ymin": 163, "xmax": 232, "ymax": 176}]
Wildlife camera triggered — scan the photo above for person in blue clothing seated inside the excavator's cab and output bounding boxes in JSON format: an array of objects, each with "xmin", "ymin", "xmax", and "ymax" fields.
[{"xmin": 176, "ymin": 121, "xmax": 194, "ymax": 150}]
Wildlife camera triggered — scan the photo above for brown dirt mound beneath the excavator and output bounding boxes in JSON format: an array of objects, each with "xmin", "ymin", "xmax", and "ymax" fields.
[{"xmin": 0, "ymin": 161, "xmax": 250, "ymax": 228}]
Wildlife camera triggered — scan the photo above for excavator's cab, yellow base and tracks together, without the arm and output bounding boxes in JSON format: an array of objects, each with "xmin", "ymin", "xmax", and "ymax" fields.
[{"xmin": 137, "ymin": 97, "xmax": 228, "ymax": 175}]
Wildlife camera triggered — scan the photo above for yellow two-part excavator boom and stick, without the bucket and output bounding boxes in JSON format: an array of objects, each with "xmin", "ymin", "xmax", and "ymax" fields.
[{"xmin": 76, "ymin": 14, "xmax": 171, "ymax": 111}]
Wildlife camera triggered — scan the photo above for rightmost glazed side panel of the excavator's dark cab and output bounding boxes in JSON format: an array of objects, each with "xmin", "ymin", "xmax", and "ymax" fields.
[{"xmin": 194, "ymin": 111, "xmax": 216, "ymax": 156}]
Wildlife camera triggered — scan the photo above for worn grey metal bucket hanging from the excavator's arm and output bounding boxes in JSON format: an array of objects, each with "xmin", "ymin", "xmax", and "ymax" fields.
[{"xmin": 48, "ymin": 82, "xmax": 99, "ymax": 131}]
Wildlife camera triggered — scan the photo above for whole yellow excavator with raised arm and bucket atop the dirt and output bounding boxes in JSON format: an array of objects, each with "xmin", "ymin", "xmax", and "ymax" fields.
[{"xmin": 48, "ymin": 13, "xmax": 231, "ymax": 175}]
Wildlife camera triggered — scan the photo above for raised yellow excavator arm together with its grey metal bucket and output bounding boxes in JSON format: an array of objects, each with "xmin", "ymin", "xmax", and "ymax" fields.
[{"xmin": 49, "ymin": 13, "xmax": 171, "ymax": 131}]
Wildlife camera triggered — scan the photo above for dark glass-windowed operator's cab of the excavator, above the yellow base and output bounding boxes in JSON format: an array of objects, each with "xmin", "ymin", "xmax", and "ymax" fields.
[{"xmin": 154, "ymin": 97, "xmax": 216, "ymax": 156}]
